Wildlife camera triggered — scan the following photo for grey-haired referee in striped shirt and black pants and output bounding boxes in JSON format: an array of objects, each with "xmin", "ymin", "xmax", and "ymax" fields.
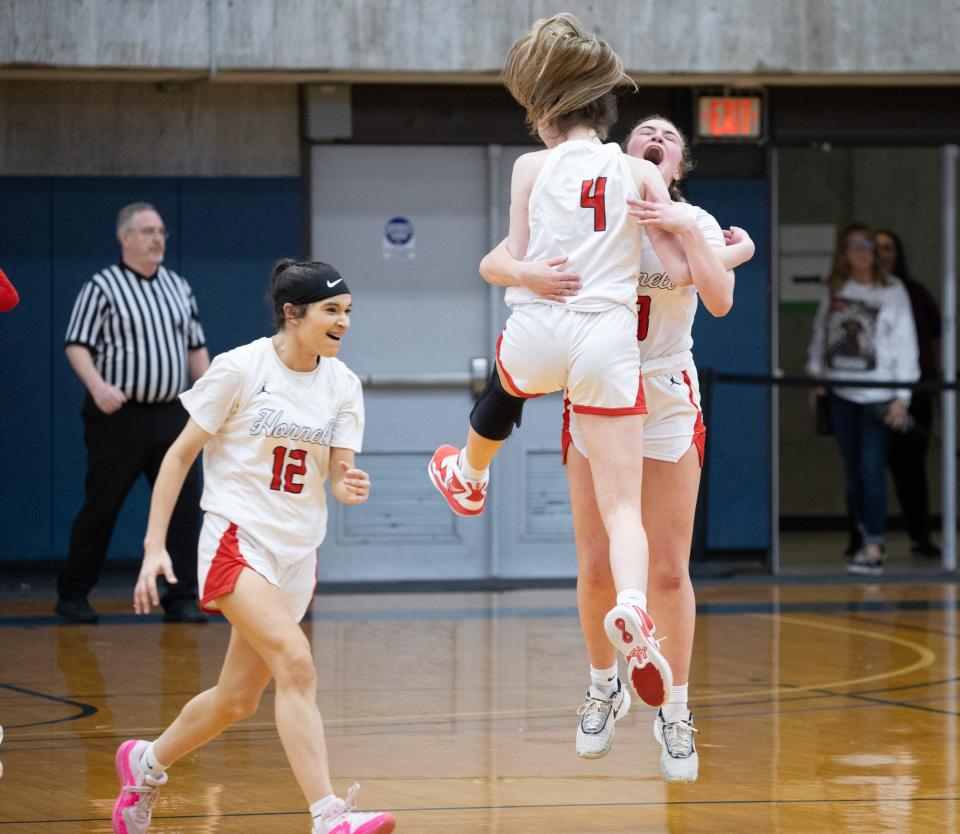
[{"xmin": 55, "ymin": 203, "xmax": 210, "ymax": 623}]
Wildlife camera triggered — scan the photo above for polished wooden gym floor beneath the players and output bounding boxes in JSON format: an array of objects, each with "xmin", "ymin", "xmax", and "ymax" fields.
[{"xmin": 0, "ymin": 582, "xmax": 960, "ymax": 834}]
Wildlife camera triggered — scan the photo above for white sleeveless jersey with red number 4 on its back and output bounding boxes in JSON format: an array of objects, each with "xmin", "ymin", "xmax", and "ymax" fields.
[{"xmin": 506, "ymin": 139, "xmax": 645, "ymax": 312}]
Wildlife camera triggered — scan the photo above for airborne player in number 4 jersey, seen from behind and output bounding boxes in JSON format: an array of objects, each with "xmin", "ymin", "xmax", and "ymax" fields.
[{"xmin": 429, "ymin": 14, "xmax": 683, "ymax": 712}]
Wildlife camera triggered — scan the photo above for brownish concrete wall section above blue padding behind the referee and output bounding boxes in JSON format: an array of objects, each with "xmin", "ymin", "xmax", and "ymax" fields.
[{"xmin": 0, "ymin": 80, "xmax": 300, "ymax": 177}]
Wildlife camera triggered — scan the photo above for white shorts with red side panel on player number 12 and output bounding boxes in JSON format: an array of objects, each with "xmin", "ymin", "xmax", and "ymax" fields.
[{"xmin": 197, "ymin": 513, "xmax": 317, "ymax": 622}]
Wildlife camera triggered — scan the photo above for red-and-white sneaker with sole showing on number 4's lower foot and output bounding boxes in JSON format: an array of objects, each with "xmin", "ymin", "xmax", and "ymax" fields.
[{"xmin": 603, "ymin": 605, "xmax": 673, "ymax": 707}]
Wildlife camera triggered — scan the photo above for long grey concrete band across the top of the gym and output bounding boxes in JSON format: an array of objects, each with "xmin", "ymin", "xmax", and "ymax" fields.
[{"xmin": 0, "ymin": 0, "xmax": 960, "ymax": 81}]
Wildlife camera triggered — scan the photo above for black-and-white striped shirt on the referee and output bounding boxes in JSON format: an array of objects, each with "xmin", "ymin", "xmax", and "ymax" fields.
[{"xmin": 66, "ymin": 264, "xmax": 206, "ymax": 403}]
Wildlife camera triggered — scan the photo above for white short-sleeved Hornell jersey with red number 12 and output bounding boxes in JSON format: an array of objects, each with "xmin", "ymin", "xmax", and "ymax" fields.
[{"xmin": 180, "ymin": 338, "xmax": 364, "ymax": 562}]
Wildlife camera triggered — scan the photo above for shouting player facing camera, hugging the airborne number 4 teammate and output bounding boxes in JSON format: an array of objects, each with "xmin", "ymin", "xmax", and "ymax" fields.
[{"xmin": 481, "ymin": 116, "xmax": 753, "ymax": 781}]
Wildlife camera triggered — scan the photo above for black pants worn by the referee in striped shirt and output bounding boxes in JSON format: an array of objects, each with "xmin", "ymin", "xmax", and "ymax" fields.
[{"xmin": 57, "ymin": 396, "xmax": 200, "ymax": 609}]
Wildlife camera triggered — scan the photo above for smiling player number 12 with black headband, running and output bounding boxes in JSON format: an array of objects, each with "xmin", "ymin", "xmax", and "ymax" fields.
[{"xmin": 113, "ymin": 260, "xmax": 395, "ymax": 834}]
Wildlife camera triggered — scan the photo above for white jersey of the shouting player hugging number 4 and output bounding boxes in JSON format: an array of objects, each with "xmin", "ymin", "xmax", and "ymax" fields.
[{"xmin": 637, "ymin": 203, "xmax": 724, "ymax": 374}]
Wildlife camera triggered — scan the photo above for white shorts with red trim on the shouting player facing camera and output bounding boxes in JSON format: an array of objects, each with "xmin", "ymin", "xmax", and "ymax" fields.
[{"xmin": 560, "ymin": 362, "xmax": 707, "ymax": 466}]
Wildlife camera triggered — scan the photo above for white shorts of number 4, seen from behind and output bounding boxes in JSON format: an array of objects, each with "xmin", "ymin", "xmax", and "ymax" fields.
[{"xmin": 497, "ymin": 304, "xmax": 646, "ymax": 415}]
